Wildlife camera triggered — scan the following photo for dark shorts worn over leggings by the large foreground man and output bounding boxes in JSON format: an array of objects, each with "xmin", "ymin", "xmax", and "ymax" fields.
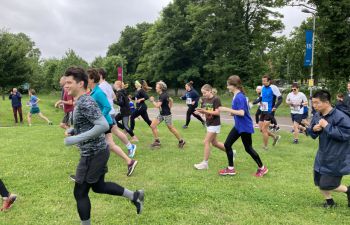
[{"xmin": 75, "ymin": 147, "xmax": 109, "ymax": 184}]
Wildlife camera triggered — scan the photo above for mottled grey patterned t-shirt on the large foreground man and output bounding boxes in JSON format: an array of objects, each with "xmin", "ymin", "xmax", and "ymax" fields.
[{"xmin": 73, "ymin": 95, "xmax": 107, "ymax": 156}]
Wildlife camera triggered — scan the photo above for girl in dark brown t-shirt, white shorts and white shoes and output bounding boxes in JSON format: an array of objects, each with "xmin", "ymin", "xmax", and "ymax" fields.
[{"xmin": 194, "ymin": 84, "xmax": 225, "ymax": 170}]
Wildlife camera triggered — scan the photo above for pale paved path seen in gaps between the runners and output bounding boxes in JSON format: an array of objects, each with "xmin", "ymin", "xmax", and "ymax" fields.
[{"xmin": 148, "ymin": 104, "xmax": 292, "ymax": 131}]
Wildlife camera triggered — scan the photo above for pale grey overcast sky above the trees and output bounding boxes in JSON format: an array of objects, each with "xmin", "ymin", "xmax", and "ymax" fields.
[{"xmin": 0, "ymin": 0, "xmax": 307, "ymax": 62}]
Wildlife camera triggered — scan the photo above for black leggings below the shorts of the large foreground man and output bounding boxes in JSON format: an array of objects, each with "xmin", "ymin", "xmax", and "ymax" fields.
[{"xmin": 74, "ymin": 175, "xmax": 124, "ymax": 221}]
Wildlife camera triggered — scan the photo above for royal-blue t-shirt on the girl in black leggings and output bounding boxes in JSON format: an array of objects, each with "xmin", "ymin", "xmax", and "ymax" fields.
[{"xmin": 232, "ymin": 92, "xmax": 254, "ymax": 134}]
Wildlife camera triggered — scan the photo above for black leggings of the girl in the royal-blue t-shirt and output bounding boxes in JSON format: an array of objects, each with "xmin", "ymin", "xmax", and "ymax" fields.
[{"xmin": 224, "ymin": 127, "xmax": 263, "ymax": 167}]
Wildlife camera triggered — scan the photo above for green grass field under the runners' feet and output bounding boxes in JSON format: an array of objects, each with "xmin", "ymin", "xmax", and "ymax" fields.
[{"xmin": 0, "ymin": 95, "xmax": 350, "ymax": 225}]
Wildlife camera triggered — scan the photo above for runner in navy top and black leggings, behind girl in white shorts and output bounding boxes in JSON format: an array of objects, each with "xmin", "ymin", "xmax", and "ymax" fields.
[{"xmin": 180, "ymin": 81, "xmax": 205, "ymax": 129}]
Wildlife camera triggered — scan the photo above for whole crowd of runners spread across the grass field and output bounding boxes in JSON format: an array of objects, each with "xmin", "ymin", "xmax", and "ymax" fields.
[{"xmin": 0, "ymin": 67, "xmax": 350, "ymax": 224}]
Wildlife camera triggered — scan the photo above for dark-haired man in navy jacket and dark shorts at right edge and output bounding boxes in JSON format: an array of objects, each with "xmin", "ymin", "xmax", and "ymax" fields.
[{"xmin": 307, "ymin": 90, "xmax": 350, "ymax": 208}]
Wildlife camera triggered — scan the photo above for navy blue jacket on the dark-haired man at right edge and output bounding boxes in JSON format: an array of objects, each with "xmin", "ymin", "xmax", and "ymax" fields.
[{"xmin": 307, "ymin": 108, "xmax": 350, "ymax": 176}]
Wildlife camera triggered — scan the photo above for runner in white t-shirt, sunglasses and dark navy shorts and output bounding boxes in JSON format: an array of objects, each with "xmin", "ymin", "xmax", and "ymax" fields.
[{"xmin": 286, "ymin": 83, "xmax": 308, "ymax": 144}]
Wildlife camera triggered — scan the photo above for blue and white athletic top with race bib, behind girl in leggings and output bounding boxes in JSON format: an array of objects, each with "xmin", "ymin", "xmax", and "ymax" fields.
[{"xmin": 260, "ymin": 85, "xmax": 281, "ymax": 113}]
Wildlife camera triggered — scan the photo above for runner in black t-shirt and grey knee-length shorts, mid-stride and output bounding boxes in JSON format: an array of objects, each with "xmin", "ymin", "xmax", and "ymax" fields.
[{"xmin": 150, "ymin": 81, "xmax": 186, "ymax": 149}]
